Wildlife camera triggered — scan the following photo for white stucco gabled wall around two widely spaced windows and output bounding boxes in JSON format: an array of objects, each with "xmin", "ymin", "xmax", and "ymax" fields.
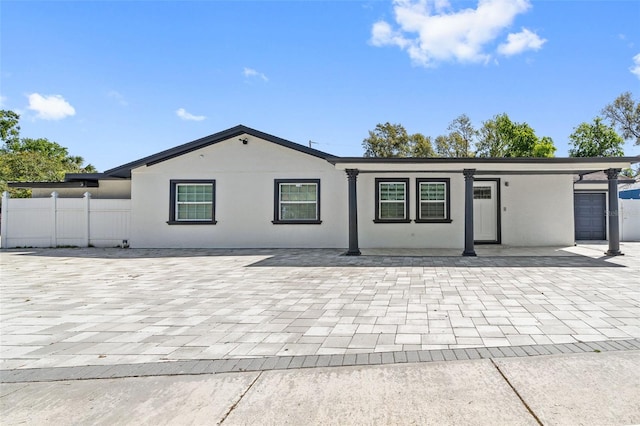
[{"xmin": 131, "ymin": 137, "xmax": 348, "ymax": 248}]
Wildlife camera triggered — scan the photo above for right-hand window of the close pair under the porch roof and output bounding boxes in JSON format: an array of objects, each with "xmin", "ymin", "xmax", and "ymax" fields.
[{"xmin": 416, "ymin": 178, "xmax": 451, "ymax": 223}]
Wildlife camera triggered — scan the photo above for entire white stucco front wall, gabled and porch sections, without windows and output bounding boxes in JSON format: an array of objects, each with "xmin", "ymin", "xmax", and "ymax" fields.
[{"xmin": 131, "ymin": 138, "xmax": 574, "ymax": 249}]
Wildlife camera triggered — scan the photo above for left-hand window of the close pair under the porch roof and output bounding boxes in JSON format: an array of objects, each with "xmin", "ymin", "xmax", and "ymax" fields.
[{"xmin": 374, "ymin": 178, "xmax": 411, "ymax": 223}]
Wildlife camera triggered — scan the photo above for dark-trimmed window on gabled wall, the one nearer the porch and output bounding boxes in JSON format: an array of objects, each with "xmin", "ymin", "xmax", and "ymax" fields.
[{"xmin": 273, "ymin": 179, "xmax": 322, "ymax": 224}]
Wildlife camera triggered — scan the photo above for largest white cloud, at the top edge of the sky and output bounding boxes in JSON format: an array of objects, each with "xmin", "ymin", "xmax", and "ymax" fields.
[{"xmin": 371, "ymin": 0, "xmax": 535, "ymax": 67}]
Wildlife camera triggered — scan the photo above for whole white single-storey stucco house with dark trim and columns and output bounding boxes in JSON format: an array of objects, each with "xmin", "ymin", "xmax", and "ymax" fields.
[{"xmin": 3, "ymin": 125, "xmax": 640, "ymax": 255}]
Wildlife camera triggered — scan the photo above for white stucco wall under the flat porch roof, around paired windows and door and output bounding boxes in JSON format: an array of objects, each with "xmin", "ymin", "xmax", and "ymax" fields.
[{"xmin": 358, "ymin": 172, "xmax": 574, "ymax": 249}]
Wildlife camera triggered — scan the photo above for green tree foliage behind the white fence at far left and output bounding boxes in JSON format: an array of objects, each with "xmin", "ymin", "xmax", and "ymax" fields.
[{"xmin": 0, "ymin": 110, "xmax": 96, "ymax": 198}]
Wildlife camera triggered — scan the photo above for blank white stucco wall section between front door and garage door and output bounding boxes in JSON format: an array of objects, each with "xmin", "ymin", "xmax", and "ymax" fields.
[{"xmin": 501, "ymin": 175, "xmax": 574, "ymax": 246}]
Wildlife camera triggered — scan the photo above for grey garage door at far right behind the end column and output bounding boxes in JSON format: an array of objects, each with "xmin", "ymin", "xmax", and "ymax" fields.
[{"xmin": 574, "ymin": 193, "xmax": 607, "ymax": 240}]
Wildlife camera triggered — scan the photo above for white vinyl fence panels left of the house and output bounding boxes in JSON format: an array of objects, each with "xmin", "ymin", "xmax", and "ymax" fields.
[{"xmin": 0, "ymin": 192, "xmax": 131, "ymax": 248}]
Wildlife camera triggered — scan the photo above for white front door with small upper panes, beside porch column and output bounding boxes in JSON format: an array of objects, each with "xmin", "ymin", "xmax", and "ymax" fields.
[{"xmin": 473, "ymin": 180, "xmax": 499, "ymax": 243}]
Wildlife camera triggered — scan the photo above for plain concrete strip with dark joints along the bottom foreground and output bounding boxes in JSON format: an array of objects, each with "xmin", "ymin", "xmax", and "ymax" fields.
[{"xmin": 0, "ymin": 351, "xmax": 640, "ymax": 425}]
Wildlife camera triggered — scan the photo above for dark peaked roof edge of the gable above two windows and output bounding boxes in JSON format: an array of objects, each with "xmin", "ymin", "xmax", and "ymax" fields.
[{"xmin": 104, "ymin": 125, "xmax": 334, "ymax": 178}]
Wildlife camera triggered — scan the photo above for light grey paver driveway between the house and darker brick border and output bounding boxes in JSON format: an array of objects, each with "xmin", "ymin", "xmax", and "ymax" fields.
[{"xmin": 0, "ymin": 243, "xmax": 640, "ymax": 369}]
